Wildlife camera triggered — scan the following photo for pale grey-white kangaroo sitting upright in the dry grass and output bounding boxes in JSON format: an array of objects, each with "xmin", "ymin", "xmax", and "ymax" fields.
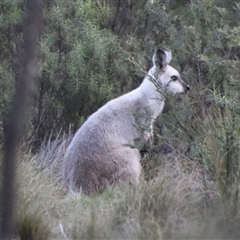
[{"xmin": 63, "ymin": 49, "xmax": 190, "ymax": 194}]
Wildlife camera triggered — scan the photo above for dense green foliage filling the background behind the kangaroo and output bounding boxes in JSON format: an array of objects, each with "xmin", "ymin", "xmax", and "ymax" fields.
[{"xmin": 0, "ymin": 0, "xmax": 240, "ymax": 238}]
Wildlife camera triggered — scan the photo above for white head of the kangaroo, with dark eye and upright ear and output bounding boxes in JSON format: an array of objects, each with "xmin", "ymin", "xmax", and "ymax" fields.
[{"xmin": 152, "ymin": 49, "xmax": 190, "ymax": 94}]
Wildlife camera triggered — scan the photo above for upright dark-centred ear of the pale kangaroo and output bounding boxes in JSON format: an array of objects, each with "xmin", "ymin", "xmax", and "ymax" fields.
[{"xmin": 152, "ymin": 48, "xmax": 172, "ymax": 70}]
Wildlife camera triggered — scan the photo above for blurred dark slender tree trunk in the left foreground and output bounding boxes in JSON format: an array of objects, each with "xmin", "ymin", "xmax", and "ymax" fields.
[{"xmin": 1, "ymin": 0, "xmax": 43, "ymax": 239}]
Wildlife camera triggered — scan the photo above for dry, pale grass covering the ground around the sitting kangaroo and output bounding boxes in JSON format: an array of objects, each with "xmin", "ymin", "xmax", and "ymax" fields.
[{"xmin": 11, "ymin": 136, "xmax": 239, "ymax": 239}]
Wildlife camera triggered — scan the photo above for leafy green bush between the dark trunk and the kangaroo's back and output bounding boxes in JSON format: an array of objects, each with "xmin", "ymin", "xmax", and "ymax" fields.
[{"xmin": 33, "ymin": 0, "xmax": 131, "ymax": 143}]
